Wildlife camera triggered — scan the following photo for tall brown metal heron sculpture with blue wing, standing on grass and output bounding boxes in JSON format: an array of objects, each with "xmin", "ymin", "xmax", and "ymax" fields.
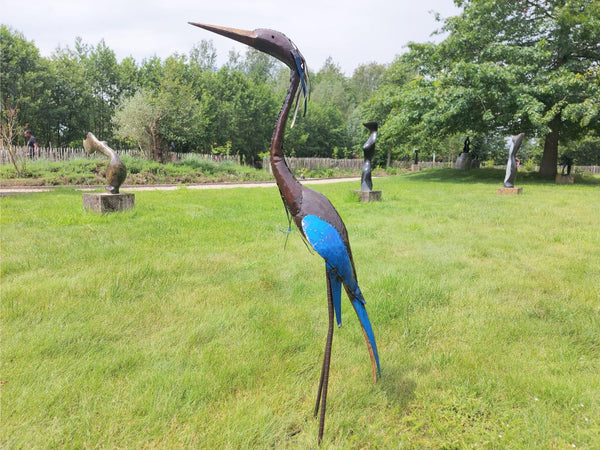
[{"xmin": 190, "ymin": 22, "xmax": 381, "ymax": 443}]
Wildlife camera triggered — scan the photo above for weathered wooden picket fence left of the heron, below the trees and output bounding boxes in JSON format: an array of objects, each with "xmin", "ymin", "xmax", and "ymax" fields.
[{"xmin": 0, "ymin": 147, "xmax": 241, "ymax": 164}]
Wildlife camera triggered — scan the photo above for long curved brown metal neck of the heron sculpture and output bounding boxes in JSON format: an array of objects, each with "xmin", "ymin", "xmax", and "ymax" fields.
[{"xmin": 270, "ymin": 70, "xmax": 302, "ymax": 216}]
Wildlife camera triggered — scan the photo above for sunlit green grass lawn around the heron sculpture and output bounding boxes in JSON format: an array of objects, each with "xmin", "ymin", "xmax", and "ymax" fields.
[{"xmin": 0, "ymin": 170, "xmax": 600, "ymax": 448}]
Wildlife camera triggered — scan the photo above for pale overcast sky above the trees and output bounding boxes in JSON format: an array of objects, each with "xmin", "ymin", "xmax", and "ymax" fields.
[{"xmin": 0, "ymin": 0, "xmax": 458, "ymax": 76}]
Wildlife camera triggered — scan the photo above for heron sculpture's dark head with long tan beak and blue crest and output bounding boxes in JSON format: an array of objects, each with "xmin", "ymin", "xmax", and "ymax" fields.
[{"xmin": 189, "ymin": 22, "xmax": 308, "ymax": 120}]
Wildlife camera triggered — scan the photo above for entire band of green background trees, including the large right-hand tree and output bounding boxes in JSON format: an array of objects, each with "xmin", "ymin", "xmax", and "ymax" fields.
[{"xmin": 0, "ymin": 0, "xmax": 600, "ymax": 174}]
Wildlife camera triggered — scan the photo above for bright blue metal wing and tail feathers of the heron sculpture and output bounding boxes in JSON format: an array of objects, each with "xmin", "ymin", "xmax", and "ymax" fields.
[{"xmin": 302, "ymin": 215, "xmax": 381, "ymax": 374}]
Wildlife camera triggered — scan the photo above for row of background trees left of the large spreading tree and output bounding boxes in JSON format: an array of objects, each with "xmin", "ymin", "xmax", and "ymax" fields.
[{"xmin": 0, "ymin": 25, "xmax": 385, "ymax": 162}]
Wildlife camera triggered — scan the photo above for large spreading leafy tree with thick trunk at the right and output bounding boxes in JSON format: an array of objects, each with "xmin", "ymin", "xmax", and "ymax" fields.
[{"xmin": 378, "ymin": 0, "xmax": 600, "ymax": 175}]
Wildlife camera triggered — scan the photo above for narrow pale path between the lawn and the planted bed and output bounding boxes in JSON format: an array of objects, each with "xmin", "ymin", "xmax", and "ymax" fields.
[{"xmin": 0, "ymin": 177, "xmax": 360, "ymax": 197}]
